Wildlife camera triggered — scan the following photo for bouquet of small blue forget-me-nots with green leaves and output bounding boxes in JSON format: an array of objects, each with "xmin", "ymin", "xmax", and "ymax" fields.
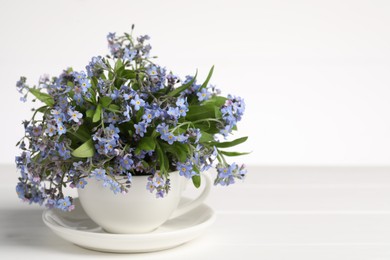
[{"xmin": 16, "ymin": 26, "xmax": 247, "ymax": 211}]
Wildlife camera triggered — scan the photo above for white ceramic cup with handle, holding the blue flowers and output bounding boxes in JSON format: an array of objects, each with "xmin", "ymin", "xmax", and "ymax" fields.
[{"xmin": 78, "ymin": 172, "xmax": 212, "ymax": 234}]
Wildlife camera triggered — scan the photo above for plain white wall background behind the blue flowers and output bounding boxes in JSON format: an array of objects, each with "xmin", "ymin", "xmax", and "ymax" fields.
[{"xmin": 0, "ymin": 0, "xmax": 390, "ymax": 165}]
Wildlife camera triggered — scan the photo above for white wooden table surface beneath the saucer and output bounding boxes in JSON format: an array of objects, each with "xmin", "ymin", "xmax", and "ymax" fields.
[{"xmin": 0, "ymin": 165, "xmax": 390, "ymax": 260}]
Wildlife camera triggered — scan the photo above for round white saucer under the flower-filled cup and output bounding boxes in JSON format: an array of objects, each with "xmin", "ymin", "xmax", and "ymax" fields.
[{"xmin": 42, "ymin": 198, "xmax": 215, "ymax": 253}]
